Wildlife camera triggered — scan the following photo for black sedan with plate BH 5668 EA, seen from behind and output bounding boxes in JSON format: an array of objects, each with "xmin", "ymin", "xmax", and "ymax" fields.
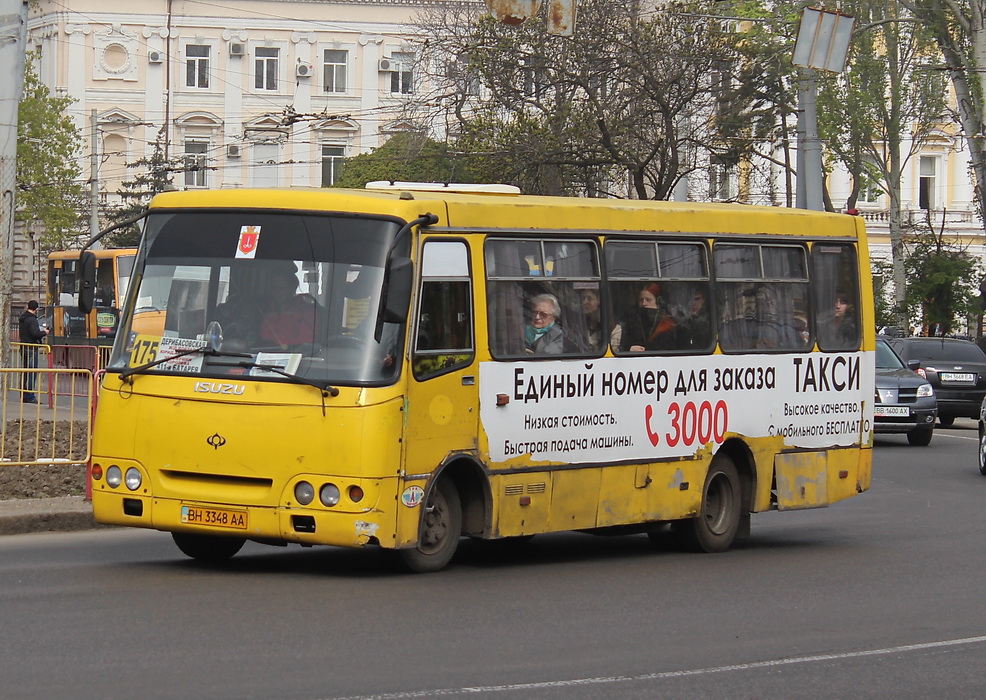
[{"xmin": 887, "ymin": 338, "xmax": 986, "ymax": 426}]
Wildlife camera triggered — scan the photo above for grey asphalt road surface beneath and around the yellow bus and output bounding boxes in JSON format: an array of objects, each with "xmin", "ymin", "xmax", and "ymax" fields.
[{"xmin": 0, "ymin": 420, "xmax": 986, "ymax": 700}]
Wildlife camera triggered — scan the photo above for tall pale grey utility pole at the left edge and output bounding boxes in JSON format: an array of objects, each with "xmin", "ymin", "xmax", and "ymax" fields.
[{"xmin": 0, "ymin": 0, "xmax": 27, "ymax": 367}]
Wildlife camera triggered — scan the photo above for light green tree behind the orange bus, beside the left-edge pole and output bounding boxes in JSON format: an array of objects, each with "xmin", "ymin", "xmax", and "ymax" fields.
[{"xmin": 17, "ymin": 47, "xmax": 82, "ymax": 250}]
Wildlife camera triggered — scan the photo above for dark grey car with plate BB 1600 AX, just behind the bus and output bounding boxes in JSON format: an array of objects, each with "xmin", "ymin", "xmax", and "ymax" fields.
[{"xmin": 873, "ymin": 338, "xmax": 938, "ymax": 445}]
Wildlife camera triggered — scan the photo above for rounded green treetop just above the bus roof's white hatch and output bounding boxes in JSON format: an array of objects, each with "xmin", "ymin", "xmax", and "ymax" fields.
[{"xmin": 333, "ymin": 133, "xmax": 481, "ymax": 187}]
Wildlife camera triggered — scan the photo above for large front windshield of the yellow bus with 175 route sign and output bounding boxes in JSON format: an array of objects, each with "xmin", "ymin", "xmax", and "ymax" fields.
[{"xmin": 107, "ymin": 210, "xmax": 406, "ymax": 385}]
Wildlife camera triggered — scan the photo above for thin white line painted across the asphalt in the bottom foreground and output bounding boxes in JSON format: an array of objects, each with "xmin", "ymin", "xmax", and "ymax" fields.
[{"xmin": 342, "ymin": 635, "xmax": 986, "ymax": 700}]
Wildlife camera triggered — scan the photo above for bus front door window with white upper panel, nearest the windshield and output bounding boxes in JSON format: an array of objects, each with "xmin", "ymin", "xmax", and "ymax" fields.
[{"xmin": 412, "ymin": 240, "xmax": 475, "ymax": 380}]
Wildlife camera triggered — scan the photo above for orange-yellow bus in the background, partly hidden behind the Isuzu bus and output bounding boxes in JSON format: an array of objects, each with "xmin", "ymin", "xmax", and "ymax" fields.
[{"xmin": 47, "ymin": 248, "xmax": 137, "ymax": 346}]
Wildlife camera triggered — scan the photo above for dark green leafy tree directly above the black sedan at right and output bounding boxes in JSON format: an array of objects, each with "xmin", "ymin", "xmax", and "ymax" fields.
[{"xmin": 905, "ymin": 228, "xmax": 982, "ymax": 335}]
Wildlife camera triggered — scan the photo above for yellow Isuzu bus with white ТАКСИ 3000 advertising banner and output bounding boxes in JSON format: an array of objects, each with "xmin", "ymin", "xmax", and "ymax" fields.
[{"xmin": 80, "ymin": 183, "xmax": 875, "ymax": 571}]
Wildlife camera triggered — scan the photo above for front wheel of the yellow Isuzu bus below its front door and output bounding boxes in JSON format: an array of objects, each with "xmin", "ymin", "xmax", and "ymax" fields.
[{"xmin": 400, "ymin": 476, "xmax": 462, "ymax": 574}]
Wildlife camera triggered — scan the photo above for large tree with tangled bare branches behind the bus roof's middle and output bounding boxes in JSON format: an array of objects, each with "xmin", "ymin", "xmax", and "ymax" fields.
[{"xmin": 411, "ymin": 0, "xmax": 735, "ymax": 199}]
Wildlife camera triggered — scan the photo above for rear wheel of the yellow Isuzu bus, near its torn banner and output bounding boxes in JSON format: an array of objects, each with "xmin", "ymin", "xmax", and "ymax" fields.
[{"xmin": 671, "ymin": 455, "xmax": 743, "ymax": 552}]
